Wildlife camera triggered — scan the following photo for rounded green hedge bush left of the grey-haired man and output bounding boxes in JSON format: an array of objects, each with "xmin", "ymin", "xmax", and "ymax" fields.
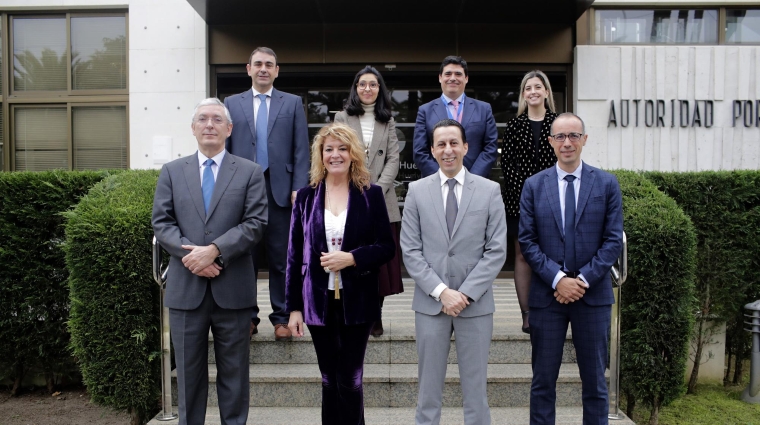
[{"xmin": 64, "ymin": 170, "xmax": 161, "ymax": 423}]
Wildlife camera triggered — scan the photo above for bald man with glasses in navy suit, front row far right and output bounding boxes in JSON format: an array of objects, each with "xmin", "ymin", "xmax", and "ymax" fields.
[{"xmin": 518, "ymin": 113, "xmax": 623, "ymax": 425}]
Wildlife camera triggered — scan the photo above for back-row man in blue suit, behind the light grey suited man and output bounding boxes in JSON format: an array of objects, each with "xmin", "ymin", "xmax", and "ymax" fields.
[{"xmin": 414, "ymin": 56, "xmax": 499, "ymax": 178}]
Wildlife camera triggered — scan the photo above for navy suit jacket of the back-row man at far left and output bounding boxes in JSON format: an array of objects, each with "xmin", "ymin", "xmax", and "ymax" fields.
[{"xmin": 224, "ymin": 89, "xmax": 309, "ymax": 207}]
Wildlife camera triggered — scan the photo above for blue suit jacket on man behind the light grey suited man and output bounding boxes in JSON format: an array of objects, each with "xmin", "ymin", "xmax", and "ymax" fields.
[{"xmin": 414, "ymin": 96, "xmax": 499, "ymax": 178}]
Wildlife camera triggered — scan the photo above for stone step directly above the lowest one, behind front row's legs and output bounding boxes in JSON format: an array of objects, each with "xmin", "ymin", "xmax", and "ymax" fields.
[{"xmin": 172, "ymin": 363, "xmax": 592, "ymax": 407}]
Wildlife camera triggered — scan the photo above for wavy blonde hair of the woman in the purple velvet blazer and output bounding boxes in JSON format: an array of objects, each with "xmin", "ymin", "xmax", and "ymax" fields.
[{"xmin": 309, "ymin": 123, "xmax": 370, "ymax": 192}]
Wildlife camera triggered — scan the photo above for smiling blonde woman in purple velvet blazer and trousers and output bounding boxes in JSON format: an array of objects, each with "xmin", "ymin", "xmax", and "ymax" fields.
[{"xmin": 285, "ymin": 123, "xmax": 395, "ymax": 425}]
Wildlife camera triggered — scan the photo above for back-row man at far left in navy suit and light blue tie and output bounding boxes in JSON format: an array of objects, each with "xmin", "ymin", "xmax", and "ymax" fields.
[{"xmin": 224, "ymin": 47, "xmax": 309, "ymax": 341}]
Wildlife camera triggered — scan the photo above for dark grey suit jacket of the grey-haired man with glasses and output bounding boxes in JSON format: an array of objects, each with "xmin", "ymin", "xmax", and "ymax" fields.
[{"xmin": 152, "ymin": 153, "xmax": 267, "ymax": 310}]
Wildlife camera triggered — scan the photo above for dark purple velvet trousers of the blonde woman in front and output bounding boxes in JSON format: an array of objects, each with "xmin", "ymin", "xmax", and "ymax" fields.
[{"xmin": 309, "ymin": 291, "xmax": 372, "ymax": 425}]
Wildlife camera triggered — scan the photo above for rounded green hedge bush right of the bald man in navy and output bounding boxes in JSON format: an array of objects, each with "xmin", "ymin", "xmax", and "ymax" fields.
[{"xmin": 615, "ymin": 171, "xmax": 696, "ymax": 417}]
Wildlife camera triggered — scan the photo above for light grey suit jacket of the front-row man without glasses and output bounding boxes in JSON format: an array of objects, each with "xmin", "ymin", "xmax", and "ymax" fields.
[{"xmin": 401, "ymin": 171, "xmax": 507, "ymax": 317}]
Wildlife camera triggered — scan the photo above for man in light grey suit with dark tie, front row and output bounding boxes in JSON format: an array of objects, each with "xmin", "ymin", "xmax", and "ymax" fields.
[{"xmin": 401, "ymin": 119, "xmax": 507, "ymax": 425}]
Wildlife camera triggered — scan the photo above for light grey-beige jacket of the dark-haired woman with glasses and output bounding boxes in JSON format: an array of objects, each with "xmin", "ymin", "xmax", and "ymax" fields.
[{"xmin": 335, "ymin": 111, "xmax": 401, "ymax": 223}]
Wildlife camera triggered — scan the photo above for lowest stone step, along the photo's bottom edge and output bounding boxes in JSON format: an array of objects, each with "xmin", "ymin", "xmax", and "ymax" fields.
[{"xmin": 148, "ymin": 406, "xmax": 635, "ymax": 425}]
